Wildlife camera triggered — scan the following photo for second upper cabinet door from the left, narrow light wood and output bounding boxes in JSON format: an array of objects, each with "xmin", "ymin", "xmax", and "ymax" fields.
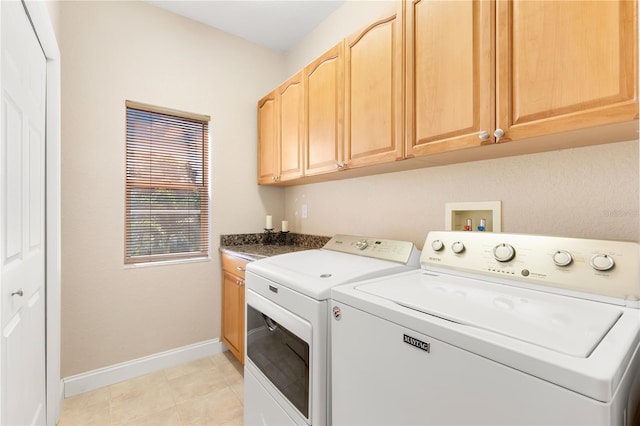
[{"xmin": 277, "ymin": 71, "xmax": 304, "ymax": 181}]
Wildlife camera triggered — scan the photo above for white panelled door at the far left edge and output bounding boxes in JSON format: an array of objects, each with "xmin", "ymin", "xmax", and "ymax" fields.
[{"xmin": 0, "ymin": 0, "xmax": 46, "ymax": 425}]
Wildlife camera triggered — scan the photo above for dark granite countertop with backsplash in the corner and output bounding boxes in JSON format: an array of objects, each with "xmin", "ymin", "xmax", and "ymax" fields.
[{"xmin": 220, "ymin": 233, "xmax": 331, "ymax": 261}]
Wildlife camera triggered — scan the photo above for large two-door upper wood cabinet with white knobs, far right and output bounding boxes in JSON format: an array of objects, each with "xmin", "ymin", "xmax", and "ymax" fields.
[{"xmin": 406, "ymin": 0, "xmax": 638, "ymax": 157}]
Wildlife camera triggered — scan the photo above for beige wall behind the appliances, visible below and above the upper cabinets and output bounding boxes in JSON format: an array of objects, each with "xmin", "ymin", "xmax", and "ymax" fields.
[{"xmin": 286, "ymin": 0, "xmax": 639, "ymax": 247}]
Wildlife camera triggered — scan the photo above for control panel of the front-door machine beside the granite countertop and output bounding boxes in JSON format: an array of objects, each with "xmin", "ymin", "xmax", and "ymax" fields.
[{"xmin": 322, "ymin": 235, "xmax": 420, "ymax": 266}]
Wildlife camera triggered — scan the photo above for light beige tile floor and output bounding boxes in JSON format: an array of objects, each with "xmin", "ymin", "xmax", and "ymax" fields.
[{"xmin": 58, "ymin": 351, "xmax": 244, "ymax": 426}]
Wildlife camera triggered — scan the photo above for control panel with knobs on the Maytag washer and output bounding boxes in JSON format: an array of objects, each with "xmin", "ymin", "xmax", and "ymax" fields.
[{"xmin": 420, "ymin": 231, "xmax": 640, "ymax": 307}]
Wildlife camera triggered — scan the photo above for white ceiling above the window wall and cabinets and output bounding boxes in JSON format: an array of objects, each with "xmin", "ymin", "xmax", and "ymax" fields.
[{"xmin": 146, "ymin": 0, "xmax": 346, "ymax": 52}]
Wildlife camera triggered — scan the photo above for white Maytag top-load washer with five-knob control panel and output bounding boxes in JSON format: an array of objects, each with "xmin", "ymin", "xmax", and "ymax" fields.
[{"xmin": 331, "ymin": 232, "xmax": 640, "ymax": 426}]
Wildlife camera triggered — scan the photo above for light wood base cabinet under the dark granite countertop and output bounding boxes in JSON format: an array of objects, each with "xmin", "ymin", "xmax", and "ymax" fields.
[{"xmin": 221, "ymin": 253, "xmax": 249, "ymax": 365}]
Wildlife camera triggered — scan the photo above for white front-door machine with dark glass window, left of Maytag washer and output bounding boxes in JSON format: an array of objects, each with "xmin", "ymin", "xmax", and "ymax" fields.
[{"xmin": 244, "ymin": 235, "xmax": 420, "ymax": 426}]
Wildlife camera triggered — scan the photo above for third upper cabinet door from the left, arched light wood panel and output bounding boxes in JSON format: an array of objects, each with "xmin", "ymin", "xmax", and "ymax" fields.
[{"xmin": 304, "ymin": 43, "xmax": 344, "ymax": 176}]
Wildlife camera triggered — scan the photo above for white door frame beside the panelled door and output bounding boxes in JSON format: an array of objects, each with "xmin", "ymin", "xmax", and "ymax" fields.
[{"xmin": 0, "ymin": 0, "xmax": 64, "ymax": 425}]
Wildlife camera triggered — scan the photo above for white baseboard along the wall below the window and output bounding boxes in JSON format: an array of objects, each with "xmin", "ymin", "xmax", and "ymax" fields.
[{"xmin": 63, "ymin": 339, "xmax": 227, "ymax": 398}]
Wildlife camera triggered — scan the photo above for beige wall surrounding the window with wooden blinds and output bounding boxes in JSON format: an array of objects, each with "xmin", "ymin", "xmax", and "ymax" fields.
[{"xmin": 59, "ymin": 1, "xmax": 284, "ymax": 377}]
